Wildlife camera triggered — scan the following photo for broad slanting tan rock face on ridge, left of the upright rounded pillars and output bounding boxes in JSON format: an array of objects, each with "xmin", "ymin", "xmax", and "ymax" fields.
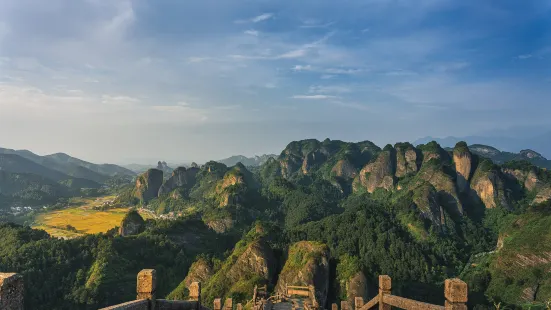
[{"xmin": 356, "ymin": 149, "xmax": 394, "ymax": 193}]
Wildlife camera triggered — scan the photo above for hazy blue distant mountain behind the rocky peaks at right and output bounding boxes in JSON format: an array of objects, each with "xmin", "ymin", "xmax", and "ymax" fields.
[{"xmin": 413, "ymin": 130, "xmax": 551, "ymax": 158}]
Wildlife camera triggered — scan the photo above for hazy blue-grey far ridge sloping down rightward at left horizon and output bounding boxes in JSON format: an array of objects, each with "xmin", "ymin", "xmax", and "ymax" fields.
[{"xmin": 0, "ymin": 148, "xmax": 135, "ymax": 183}]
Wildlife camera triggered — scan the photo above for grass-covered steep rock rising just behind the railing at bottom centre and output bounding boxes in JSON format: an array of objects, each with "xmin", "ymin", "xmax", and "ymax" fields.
[{"xmin": 276, "ymin": 241, "xmax": 329, "ymax": 307}]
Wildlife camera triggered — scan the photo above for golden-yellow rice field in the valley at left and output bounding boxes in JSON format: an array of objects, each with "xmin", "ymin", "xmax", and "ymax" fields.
[{"xmin": 33, "ymin": 196, "xmax": 150, "ymax": 238}]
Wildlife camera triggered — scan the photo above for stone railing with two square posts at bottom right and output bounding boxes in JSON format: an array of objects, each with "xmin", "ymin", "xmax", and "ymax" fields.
[{"xmin": 331, "ymin": 276, "xmax": 468, "ymax": 310}]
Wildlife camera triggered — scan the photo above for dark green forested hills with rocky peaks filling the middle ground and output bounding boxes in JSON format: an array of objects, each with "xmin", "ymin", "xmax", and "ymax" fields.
[{"xmin": 0, "ymin": 139, "xmax": 551, "ymax": 309}]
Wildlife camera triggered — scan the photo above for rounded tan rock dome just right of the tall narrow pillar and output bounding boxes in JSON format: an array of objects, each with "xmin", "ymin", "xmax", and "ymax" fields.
[{"xmin": 471, "ymin": 161, "xmax": 510, "ymax": 209}]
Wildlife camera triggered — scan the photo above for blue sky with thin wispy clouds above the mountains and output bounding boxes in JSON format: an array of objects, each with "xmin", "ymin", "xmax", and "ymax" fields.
[{"xmin": 0, "ymin": 0, "xmax": 551, "ymax": 163}]
